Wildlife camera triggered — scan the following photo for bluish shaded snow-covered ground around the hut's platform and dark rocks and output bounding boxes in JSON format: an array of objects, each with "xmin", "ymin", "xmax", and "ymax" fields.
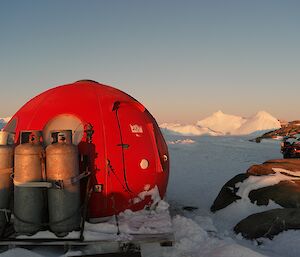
[{"xmin": 0, "ymin": 116, "xmax": 300, "ymax": 257}]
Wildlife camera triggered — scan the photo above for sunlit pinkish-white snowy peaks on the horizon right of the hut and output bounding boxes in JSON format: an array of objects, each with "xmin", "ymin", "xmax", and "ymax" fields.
[{"xmin": 160, "ymin": 111, "xmax": 281, "ymax": 136}]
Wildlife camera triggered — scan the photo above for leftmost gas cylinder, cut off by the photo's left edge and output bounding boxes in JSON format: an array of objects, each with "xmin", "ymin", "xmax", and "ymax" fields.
[{"xmin": 0, "ymin": 131, "xmax": 14, "ymax": 234}]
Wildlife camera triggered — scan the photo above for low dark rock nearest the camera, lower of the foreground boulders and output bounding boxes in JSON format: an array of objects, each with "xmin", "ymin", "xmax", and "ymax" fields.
[{"xmin": 234, "ymin": 208, "xmax": 300, "ymax": 239}]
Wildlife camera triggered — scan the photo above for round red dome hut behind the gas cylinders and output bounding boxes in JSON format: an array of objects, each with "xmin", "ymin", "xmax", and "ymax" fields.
[{"xmin": 4, "ymin": 80, "xmax": 169, "ymax": 218}]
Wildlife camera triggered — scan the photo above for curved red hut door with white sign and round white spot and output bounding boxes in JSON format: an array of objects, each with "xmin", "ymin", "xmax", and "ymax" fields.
[{"xmin": 114, "ymin": 102, "xmax": 158, "ymax": 193}]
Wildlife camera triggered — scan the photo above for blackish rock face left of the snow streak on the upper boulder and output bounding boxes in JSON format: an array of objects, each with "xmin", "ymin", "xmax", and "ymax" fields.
[{"xmin": 210, "ymin": 173, "xmax": 249, "ymax": 212}]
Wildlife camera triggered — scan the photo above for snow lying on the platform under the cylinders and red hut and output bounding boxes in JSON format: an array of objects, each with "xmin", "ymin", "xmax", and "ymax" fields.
[{"xmin": 17, "ymin": 200, "xmax": 172, "ymax": 241}]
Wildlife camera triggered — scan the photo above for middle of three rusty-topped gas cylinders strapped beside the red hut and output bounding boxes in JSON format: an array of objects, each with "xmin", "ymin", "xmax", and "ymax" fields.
[{"xmin": 14, "ymin": 131, "xmax": 46, "ymax": 235}]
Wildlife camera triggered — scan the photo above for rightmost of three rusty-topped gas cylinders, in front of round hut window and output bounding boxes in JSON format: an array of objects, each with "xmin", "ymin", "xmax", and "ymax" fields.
[{"xmin": 46, "ymin": 130, "xmax": 81, "ymax": 236}]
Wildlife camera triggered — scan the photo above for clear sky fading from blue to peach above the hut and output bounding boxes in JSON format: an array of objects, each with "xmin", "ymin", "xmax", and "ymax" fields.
[{"xmin": 0, "ymin": 0, "xmax": 300, "ymax": 122}]
